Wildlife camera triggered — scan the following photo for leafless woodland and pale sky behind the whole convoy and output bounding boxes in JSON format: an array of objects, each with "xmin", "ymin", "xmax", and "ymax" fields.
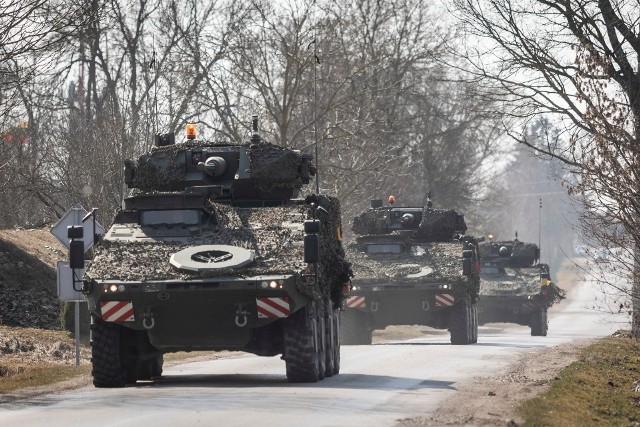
[{"xmin": 0, "ymin": 0, "xmax": 640, "ymax": 332}]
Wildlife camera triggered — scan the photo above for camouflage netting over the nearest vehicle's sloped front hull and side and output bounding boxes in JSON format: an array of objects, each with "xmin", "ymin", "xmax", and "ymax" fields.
[{"xmin": 85, "ymin": 196, "xmax": 352, "ymax": 302}]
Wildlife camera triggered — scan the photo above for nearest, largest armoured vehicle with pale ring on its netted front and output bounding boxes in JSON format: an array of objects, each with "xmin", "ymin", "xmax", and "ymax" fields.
[{"xmin": 71, "ymin": 118, "xmax": 351, "ymax": 387}]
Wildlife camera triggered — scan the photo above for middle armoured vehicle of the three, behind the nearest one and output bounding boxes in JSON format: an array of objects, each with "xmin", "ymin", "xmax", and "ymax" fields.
[{"xmin": 341, "ymin": 198, "xmax": 480, "ymax": 344}]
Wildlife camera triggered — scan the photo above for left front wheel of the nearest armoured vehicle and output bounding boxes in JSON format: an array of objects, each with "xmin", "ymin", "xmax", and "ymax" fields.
[{"xmin": 91, "ymin": 317, "xmax": 130, "ymax": 387}]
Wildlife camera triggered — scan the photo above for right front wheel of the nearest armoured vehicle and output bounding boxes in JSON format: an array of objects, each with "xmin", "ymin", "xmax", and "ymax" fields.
[{"xmin": 283, "ymin": 302, "xmax": 320, "ymax": 382}]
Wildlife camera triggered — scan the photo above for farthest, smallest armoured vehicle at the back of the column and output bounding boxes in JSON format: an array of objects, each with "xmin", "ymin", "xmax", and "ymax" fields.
[{"xmin": 478, "ymin": 238, "xmax": 565, "ymax": 336}]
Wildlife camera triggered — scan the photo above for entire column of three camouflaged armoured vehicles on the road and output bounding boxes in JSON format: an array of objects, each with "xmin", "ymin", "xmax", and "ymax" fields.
[{"xmin": 60, "ymin": 109, "xmax": 564, "ymax": 387}]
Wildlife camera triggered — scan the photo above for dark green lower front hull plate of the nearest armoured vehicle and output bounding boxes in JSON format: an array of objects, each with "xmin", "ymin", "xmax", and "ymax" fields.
[{"xmin": 89, "ymin": 276, "xmax": 309, "ymax": 355}]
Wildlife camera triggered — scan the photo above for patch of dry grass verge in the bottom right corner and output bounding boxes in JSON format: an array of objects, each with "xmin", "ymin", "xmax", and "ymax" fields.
[{"xmin": 519, "ymin": 338, "xmax": 640, "ymax": 426}]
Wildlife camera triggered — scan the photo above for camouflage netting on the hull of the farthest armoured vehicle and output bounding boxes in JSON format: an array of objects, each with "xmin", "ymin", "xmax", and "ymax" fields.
[{"xmin": 480, "ymin": 265, "xmax": 565, "ymax": 306}]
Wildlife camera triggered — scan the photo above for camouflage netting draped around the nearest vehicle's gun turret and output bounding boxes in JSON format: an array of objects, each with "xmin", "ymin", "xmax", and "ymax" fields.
[{"xmin": 131, "ymin": 141, "xmax": 315, "ymax": 192}]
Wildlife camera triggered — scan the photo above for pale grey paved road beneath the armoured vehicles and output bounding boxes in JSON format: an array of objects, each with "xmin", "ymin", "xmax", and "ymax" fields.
[{"xmin": 0, "ymin": 260, "xmax": 626, "ymax": 427}]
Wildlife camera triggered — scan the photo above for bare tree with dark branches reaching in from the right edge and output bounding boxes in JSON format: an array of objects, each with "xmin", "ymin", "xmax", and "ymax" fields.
[{"xmin": 454, "ymin": 0, "xmax": 640, "ymax": 337}]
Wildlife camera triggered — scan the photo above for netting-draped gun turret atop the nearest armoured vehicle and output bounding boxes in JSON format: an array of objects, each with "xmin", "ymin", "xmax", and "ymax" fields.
[{"xmin": 124, "ymin": 119, "xmax": 316, "ymax": 202}]
